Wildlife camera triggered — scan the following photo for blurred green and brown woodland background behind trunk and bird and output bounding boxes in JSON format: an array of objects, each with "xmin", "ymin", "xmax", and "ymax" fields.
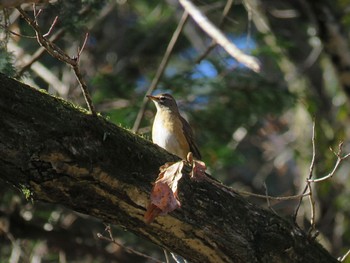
[{"xmin": 0, "ymin": 0, "xmax": 350, "ymax": 262}]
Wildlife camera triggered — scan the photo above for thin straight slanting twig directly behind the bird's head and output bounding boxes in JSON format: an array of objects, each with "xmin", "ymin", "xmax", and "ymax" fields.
[{"xmin": 132, "ymin": 11, "xmax": 188, "ymax": 133}]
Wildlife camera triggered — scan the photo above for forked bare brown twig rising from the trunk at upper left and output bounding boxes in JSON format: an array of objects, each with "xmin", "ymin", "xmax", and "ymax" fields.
[{"xmin": 17, "ymin": 6, "xmax": 96, "ymax": 116}]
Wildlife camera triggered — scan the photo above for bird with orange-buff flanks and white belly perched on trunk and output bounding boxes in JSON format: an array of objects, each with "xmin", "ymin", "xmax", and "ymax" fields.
[{"xmin": 147, "ymin": 93, "xmax": 201, "ymax": 160}]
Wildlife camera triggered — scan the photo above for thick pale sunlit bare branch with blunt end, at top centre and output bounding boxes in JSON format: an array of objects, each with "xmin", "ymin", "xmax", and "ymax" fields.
[{"xmin": 179, "ymin": 0, "xmax": 260, "ymax": 72}]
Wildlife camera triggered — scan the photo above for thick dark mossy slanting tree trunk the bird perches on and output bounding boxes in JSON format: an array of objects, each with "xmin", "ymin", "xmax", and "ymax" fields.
[{"xmin": 0, "ymin": 74, "xmax": 338, "ymax": 263}]
